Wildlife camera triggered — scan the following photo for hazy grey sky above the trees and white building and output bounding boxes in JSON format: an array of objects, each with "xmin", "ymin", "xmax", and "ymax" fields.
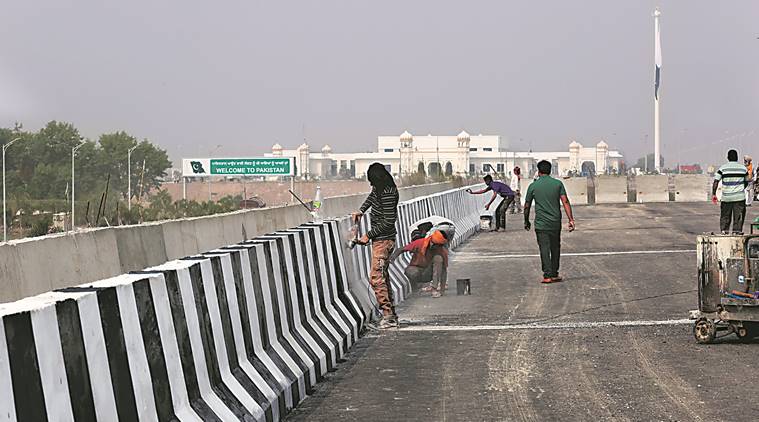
[{"xmin": 0, "ymin": 0, "xmax": 759, "ymax": 164}]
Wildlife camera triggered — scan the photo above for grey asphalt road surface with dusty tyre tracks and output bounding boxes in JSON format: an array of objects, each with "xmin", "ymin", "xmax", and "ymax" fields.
[{"xmin": 289, "ymin": 203, "xmax": 759, "ymax": 421}]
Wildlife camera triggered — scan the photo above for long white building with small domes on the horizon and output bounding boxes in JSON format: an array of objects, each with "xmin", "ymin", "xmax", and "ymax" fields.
[{"xmin": 266, "ymin": 131, "xmax": 623, "ymax": 179}]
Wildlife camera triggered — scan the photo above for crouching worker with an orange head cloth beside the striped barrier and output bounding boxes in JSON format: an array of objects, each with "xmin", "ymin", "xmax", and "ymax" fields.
[{"xmin": 390, "ymin": 230, "xmax": 448, "ymax": 298}]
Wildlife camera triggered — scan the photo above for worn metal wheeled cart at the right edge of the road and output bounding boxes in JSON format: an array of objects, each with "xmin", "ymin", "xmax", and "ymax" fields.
[{"xmin": 690, "ymin": 234, "xmax": 759, "ymax": 343}]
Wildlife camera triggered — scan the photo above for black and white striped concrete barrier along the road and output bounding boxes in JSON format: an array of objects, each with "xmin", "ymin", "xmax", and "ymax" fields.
[{"xmin": 0, "ymin": 186, "xmax": 481, "ymax": 421}]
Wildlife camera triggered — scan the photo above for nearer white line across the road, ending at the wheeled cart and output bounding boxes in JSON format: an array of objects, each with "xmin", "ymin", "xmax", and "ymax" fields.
[{"xmin": 400, "ymin": 318, "xmax": 693, "ymax": 331}]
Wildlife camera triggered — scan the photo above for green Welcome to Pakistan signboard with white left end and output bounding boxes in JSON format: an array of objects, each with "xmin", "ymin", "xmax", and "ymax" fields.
[{"xmin": 182, "ymin": 157, "xmax": 294, "ymax": 177}]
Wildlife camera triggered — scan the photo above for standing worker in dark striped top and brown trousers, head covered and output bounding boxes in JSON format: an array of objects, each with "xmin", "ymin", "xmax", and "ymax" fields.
[{"xmin": 351, "ymin": 163, "xmax": 398, "ymax": 329}]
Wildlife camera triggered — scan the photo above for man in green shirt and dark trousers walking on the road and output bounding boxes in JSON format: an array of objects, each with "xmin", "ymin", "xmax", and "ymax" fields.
[{"xmin": 524, "ymin": 160, "xmax": 575, "ymax": 283}]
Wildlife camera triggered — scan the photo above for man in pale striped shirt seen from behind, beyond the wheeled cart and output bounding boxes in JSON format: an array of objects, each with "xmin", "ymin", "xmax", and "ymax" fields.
[{"xmin": 712, "ymin": 149, "xmax": 751, "ymax": 233}]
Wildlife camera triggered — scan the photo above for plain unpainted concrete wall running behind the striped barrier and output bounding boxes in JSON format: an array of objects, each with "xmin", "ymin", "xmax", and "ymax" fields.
[{"xmin": 0, "ymin": 183, "xmax": 452, "ymax": 303}]
